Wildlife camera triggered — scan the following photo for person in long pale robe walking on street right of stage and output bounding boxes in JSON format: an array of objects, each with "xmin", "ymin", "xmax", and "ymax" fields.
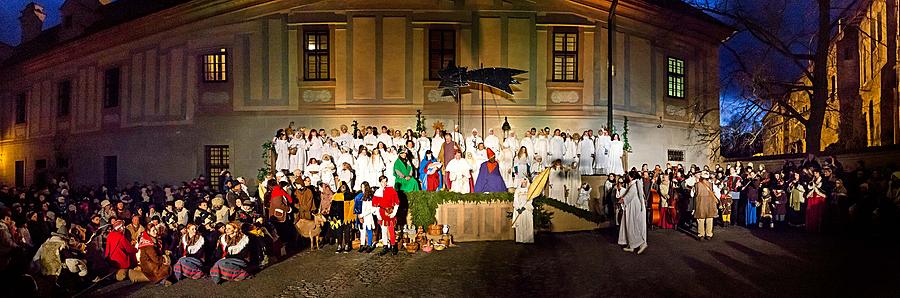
[{"xmin": 618, "ymin": 179, "xmax": 647, "ymax": 249}]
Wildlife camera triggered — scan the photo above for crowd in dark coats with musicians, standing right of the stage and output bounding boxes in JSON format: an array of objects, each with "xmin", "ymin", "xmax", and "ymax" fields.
[{"xmin": 600, "ymin": 154, "xmax": 900, "ymax": 252}]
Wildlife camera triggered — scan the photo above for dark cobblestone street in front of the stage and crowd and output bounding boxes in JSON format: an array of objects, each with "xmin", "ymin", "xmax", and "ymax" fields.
[{"xmin": 82, "ymin": 228, "xmax": 900, "ymax": 297}]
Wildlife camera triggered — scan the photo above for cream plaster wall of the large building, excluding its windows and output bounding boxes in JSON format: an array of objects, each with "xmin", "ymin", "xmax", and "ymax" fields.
[{"xmin": 0, "ymin": 0, "xmax": 718, "ymax": 183}]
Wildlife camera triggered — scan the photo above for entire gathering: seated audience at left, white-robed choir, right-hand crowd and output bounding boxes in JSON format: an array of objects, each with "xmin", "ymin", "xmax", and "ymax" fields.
[{"xmin": 0, "ymin": 120, "xmax": 900, "ymax": 290}]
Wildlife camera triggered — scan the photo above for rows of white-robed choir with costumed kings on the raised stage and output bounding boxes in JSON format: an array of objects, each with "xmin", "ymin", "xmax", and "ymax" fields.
[{"xmin": 272, "ymin": 124, "xmax": 625, "ymax": 209}]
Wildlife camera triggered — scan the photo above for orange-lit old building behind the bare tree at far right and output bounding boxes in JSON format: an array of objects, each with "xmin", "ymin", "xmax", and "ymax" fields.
[{"xmin": 763, "ymin": 1, "xmax": 900, "ymax": 155}]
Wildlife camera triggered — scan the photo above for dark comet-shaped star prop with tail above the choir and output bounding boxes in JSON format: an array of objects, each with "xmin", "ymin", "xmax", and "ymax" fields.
[{"xmin": 438, "ymin": 61, "xmax": 527, "ymax": 97}]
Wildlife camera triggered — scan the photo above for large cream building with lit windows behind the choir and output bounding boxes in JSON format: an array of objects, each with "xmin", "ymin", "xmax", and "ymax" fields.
[{"xmin": 0, "ymin": 0, "xmax": 732, "ymax": 185}]
